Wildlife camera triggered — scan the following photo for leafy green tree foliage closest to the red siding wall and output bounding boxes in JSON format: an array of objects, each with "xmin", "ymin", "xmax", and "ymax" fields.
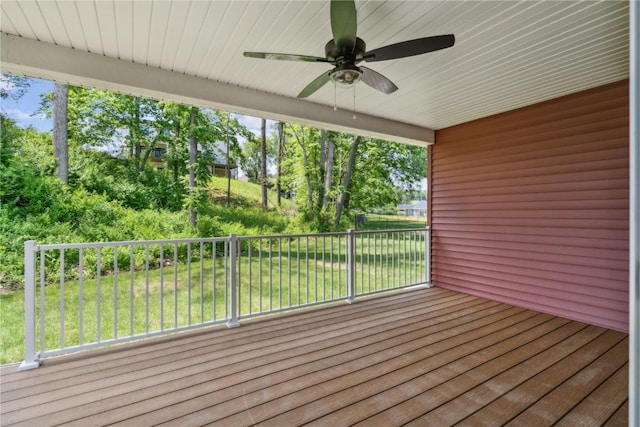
[{"xmin": 281, "ymin": 124, "xmax": 427, "ymax": 231}]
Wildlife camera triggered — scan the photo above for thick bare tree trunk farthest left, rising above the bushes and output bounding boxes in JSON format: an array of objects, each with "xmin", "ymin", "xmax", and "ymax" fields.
[{"xmin": 53, "ymin": 83, "xmax": 69, "ymax": 184}]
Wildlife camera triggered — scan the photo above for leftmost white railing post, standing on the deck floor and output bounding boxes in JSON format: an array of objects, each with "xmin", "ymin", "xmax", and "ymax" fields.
[{"xmin": 18, "ymin": 240, "xmax": 40, "ymax": 371}]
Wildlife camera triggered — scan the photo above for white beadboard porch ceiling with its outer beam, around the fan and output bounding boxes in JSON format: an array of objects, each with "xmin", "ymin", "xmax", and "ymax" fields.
[{"xmin": 0, "ymin": 0, "xmax": 629, "ymax": 143}]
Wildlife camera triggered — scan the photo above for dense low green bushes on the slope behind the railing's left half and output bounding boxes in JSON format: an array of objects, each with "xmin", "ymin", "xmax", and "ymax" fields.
[{"xmin": 0, "ymin": 115, "xmax": 293, "ymax": 289}]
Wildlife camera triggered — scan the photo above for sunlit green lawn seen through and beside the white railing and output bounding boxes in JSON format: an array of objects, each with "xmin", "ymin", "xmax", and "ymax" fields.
[{"xmin": 0, "ymin": 233, "xmax": 424, "ymax": 364}]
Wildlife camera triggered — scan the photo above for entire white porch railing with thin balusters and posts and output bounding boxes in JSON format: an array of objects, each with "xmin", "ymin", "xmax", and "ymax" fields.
[{"xmin": 21, "ymin": 228, "xmax": 430, "ymax": 369}]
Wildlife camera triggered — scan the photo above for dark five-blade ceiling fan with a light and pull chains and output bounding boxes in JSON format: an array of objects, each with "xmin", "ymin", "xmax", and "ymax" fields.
[{"xmin": 244, "ymin": 0, "xmax": 455, "ymax": 98}]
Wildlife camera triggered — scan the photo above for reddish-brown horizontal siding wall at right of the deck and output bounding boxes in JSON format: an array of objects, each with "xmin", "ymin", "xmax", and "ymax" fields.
[{"xmin": 430, "ymin": 81, "xmax": 629, "ymax": 331}]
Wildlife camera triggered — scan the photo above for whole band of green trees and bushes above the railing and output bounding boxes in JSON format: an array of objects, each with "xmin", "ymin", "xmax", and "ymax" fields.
[{"xmin": 0, "ymin": 80, "xmax": 426, "ymax": 287}]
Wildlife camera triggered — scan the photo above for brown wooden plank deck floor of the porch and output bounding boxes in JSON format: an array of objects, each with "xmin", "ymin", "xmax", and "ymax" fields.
[{"xmin": 0, "ymin": 288, "xmax": 628, "ymax": 427}]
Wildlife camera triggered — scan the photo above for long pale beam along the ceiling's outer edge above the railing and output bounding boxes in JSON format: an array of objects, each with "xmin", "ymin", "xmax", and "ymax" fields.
[{"xmin": 0, "ymin": 33, "xmax": 435, "ymax": 146}]
